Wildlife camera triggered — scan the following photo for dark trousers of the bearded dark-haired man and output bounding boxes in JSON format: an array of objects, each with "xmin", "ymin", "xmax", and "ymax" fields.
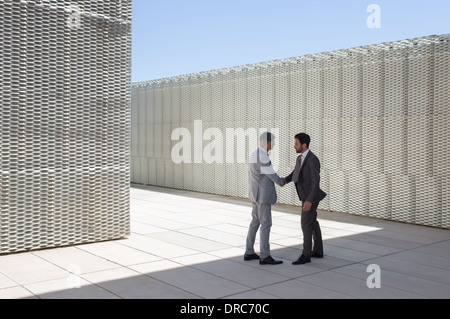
[{"xmin": 301, "ymin": 203, "xmax": 323, "ymax": 257}]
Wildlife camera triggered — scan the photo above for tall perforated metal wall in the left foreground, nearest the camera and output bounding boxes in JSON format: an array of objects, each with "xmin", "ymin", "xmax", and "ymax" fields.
[{"xmin": 0, "ymin": 0, "xmax": 131, "ymax": 254}]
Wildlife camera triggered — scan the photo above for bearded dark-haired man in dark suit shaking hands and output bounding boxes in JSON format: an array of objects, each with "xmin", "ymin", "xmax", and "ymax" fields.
[{"xmin": 285, "ymin": 133, "xmax": 327, "ymax": 265}]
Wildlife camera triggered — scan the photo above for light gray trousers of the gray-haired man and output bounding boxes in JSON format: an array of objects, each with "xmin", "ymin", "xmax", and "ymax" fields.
[{"xmin": 245, "ymin": 203, "xmax": 272, "ymax": 259}]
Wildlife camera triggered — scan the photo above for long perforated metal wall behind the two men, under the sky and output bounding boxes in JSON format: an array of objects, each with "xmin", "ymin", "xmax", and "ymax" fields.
[{"xmin": 132, "ymin": 34, "xmax": 450, "ymax": 228}]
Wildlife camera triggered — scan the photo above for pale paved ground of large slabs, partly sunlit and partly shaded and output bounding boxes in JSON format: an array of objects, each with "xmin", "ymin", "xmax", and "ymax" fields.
[{"xmin": 0, "ymin": 185, "xmax": 450, "ymax": 299}]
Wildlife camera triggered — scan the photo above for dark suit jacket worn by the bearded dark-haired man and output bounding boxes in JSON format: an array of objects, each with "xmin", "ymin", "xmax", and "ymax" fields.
[{"xmin": 286, "ymin": 150, "xmax": 327, "ymax": 203}]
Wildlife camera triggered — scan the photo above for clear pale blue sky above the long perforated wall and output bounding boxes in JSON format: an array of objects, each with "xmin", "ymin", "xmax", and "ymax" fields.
[{"xmin": 132, "ymin": 0, "xmax": 450, "ymax": 82}]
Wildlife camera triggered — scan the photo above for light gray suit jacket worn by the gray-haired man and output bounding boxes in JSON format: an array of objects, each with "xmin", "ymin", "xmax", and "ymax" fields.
[{"xmin": 249, "ymin": 147, "xmax": 283, "ymax": 204}]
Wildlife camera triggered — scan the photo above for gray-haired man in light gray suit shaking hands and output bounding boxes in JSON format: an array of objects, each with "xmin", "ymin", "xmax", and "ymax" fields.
[{"xmin": 244, "ymin": 132, "xmax": 284, "ymax": 265}]
